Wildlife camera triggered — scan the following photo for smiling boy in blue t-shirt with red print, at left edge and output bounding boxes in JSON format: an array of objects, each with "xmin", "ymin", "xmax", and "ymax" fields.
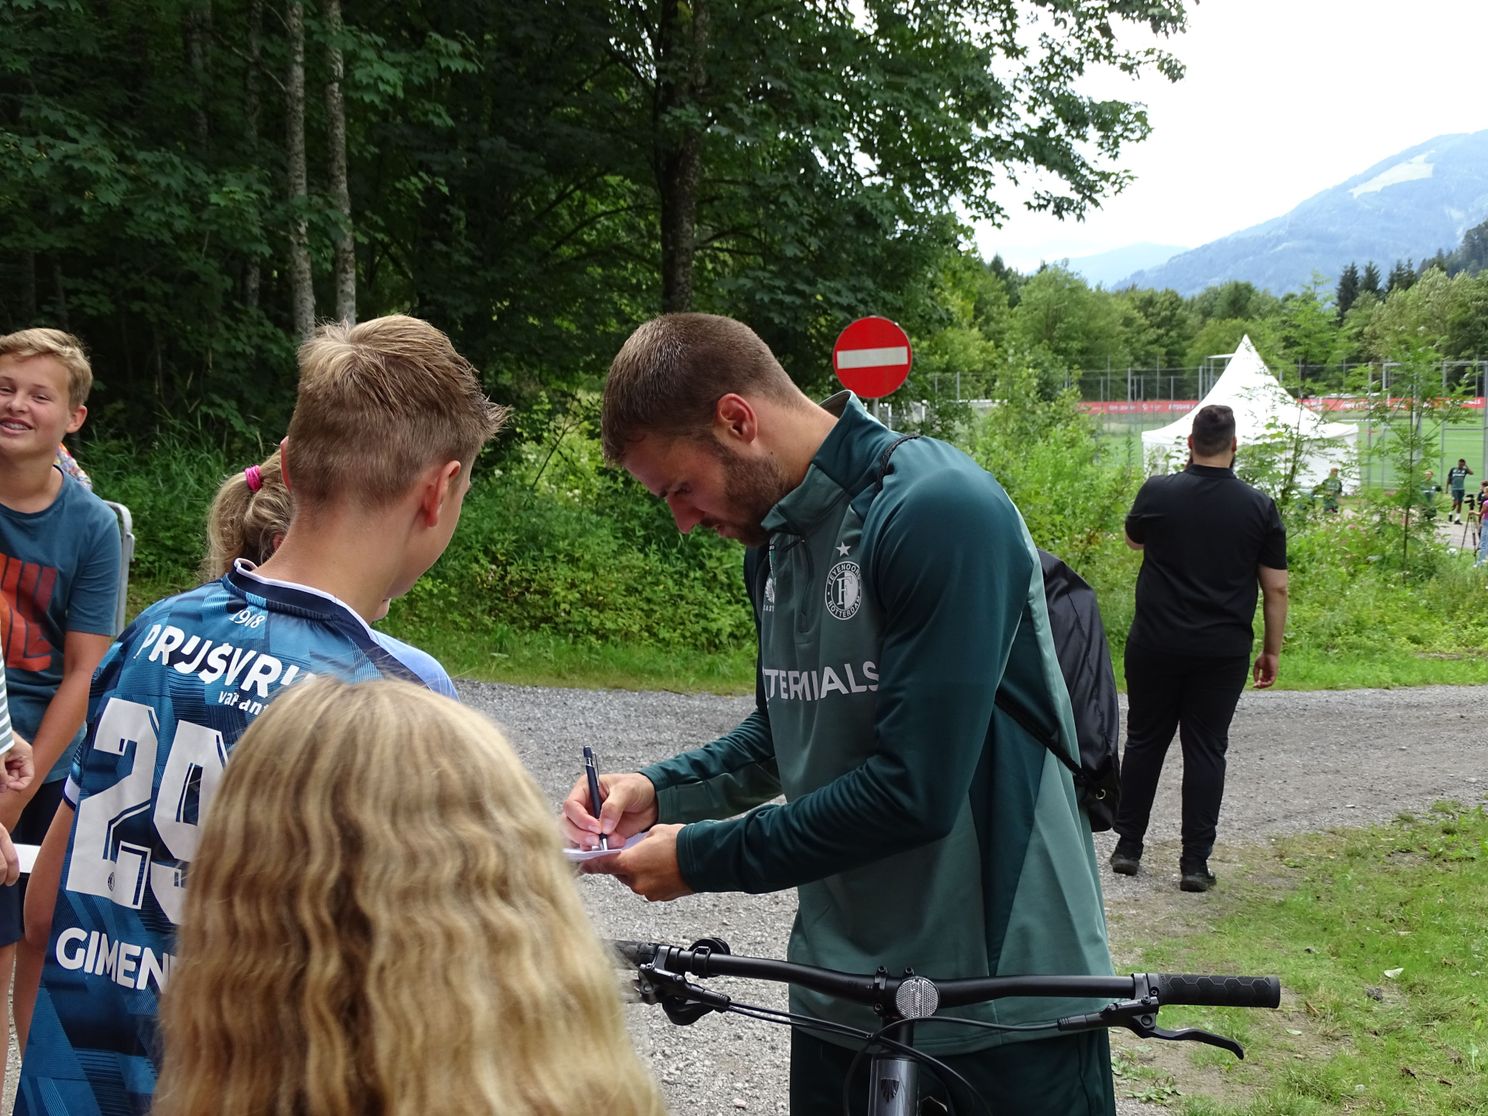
[{"xmin": 0, "ymin": 329, "xmax": 119, "ymax": 1089}]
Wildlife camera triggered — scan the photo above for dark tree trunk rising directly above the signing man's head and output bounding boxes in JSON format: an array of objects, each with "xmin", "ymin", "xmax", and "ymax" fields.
[{"xmin": 652, "ymin": 0, "xmax": 708, "ymax": 314}]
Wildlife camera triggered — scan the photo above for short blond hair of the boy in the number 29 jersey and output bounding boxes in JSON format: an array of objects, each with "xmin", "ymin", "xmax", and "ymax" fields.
[{"xmin": 289, "ymin": 314, "xmax": 507, "ymax": 507}]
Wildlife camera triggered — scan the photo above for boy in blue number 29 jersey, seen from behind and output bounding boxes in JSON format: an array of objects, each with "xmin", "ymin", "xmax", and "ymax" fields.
[{"xmin": 15, "ymin": 315, "xmax": 506, "ymax": 1116}]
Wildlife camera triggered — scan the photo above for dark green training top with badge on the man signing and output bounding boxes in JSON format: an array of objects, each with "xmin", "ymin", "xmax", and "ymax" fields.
[{"xmin": 644, "ymin": 393, "xmax": 1110, "ymax": 1054}]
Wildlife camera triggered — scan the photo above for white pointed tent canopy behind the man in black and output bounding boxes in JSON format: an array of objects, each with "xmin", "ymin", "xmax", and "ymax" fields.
[{"xmin": 1141, "ymin": 336, "xmax": 1359, "ymax": 490}]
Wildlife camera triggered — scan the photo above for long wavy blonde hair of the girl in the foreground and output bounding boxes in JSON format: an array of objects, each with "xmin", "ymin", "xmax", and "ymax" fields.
[{"xmin": 153, "ymin": 679, "xmax": 662, "ymax": 1116}]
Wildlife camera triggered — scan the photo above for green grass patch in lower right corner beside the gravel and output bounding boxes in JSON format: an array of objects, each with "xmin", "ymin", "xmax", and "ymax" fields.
[{"xmin": 1113, "ymin": 804, "xmax": 1488, "ymax": 1116}]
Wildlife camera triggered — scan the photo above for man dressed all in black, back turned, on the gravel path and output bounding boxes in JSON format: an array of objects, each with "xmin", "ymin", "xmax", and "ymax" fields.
[{"xmin": 1110, "ymin": 405, "xmax": 1287, "ymax": 891}]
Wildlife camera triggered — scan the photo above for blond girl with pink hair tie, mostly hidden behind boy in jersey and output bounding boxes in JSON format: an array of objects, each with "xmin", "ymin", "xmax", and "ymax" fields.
[{"xmin": 201, "ymin": 449, "xmax": 460, "ymax": 701}]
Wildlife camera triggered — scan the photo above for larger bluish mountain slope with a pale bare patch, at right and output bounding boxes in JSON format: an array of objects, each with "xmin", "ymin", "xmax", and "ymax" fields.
[{"xmin": 1116, "ymin": 129, "xmax": 1488, "ymax": 295}]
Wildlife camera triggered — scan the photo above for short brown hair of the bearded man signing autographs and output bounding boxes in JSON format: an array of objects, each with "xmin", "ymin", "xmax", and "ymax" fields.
[{"xmin": 600, "ymin": 314, "xmax": 809, "ymax": 463}]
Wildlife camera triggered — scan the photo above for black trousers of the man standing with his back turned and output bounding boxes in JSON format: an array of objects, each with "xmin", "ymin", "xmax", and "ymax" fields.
[{"xmin": 1115, "ymin": 646, "xmax": 1250, "ymax": 868}]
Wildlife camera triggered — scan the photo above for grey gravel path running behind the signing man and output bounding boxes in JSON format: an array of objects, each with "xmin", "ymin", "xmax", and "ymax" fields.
[{"xmin": 7, "ymin": 682, "xmax": 1488, "ymax": 1116}]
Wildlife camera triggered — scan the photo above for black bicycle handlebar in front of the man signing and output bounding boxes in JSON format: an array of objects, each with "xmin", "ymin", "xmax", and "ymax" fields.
[{"xmin": 612, "ymin": 942, "xmax": 1281, "ymax": 1010}]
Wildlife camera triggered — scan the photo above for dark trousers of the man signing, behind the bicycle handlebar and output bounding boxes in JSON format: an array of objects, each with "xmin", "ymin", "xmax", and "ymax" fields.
[{"xmin": 790, "ymin": 1030, "xmax": 1116, "ymax": 1116}]
